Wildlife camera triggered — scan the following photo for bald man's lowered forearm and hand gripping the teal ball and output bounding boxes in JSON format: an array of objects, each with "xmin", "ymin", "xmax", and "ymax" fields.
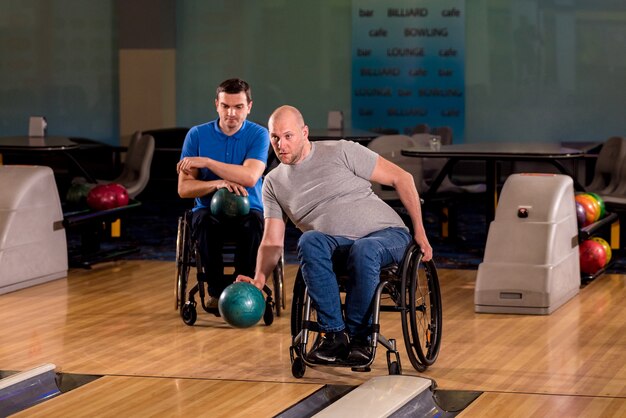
[{"xmin": 237, "ymin": 218, "xmax": 285, "ymax": 289}]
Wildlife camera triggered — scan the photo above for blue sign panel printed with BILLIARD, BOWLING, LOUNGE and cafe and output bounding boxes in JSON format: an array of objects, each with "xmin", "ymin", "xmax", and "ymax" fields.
[{"xmin": 352, "ymin": 0, "xmax": 465, "ymax": 143}]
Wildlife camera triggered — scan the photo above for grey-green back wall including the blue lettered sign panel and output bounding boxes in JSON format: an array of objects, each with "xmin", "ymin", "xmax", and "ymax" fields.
[{"xmin": 0, "ymin": 0, "xmax": 626, "ymax": 144}]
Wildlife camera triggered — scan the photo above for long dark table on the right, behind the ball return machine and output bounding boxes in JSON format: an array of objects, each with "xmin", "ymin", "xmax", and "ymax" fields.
[{"xmin": 401, "ymin": 142, "xmax": 586, "ymax": 228}]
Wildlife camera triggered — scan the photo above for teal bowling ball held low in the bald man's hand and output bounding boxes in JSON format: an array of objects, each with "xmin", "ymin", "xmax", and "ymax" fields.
[{"xmin": 217, "ymin": 282, "xmax": 265, "ymax": 328}]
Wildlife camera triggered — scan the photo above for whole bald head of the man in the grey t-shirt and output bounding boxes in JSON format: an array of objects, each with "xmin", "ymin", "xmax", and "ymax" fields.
[{"xmin": 267, "ymin": 105, "xmax": 311, "ymax": 165}]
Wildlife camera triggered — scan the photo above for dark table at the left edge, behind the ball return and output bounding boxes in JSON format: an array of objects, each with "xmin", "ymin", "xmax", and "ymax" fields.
[{"xmin": 0, "ymin": 136, "xmax": 96, "ymax": 183}]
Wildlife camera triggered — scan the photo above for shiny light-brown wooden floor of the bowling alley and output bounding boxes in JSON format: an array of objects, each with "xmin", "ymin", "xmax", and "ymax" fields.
[{"xmin": 0, "ymin": 261, "xmax": 626, "ymax": 417}]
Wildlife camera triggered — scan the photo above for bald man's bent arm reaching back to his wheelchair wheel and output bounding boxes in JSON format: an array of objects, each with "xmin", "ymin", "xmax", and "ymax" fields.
[{"xmin": 370, "ymin": 156, "xmax": 433, "ymax": 261}]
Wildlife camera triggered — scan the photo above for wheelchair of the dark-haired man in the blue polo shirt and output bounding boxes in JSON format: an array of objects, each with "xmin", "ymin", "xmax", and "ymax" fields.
[{"xmin": 175, "ymin": 210, "xmax": 286, "ymax": 326}]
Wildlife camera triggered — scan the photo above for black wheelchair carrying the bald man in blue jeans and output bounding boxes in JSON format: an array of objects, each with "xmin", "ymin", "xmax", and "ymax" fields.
[{"xmin": 289, "ymin": 243, "xmax": 442, "ymax": 378}]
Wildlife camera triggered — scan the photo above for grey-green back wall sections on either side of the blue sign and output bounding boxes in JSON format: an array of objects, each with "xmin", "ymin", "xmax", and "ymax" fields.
[{"xmin": 0, "ymin": 0, "xmax": 626, "ymax": 143}]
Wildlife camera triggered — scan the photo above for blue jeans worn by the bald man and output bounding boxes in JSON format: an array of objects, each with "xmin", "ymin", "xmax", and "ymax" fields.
[{"xmin": 298, "ymin": 228, "xmax": 412, "ymax": 338}]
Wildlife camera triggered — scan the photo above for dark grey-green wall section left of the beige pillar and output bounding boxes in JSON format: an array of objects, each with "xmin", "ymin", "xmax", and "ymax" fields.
[{"xmin": 0, "ymin": 0, "xmax": 119, "ymax": 143}]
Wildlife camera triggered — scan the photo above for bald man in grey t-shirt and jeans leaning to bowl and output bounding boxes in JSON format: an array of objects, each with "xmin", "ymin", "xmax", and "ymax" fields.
[{"xmin": 237, "ymin": 106, "xmax": 432, "ymax": 364}]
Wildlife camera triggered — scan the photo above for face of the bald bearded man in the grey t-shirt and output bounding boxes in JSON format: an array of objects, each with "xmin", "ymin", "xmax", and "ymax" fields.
[{"xmin": 268, "ymin": 113, "xmax": 309, "ymax": 165}]
